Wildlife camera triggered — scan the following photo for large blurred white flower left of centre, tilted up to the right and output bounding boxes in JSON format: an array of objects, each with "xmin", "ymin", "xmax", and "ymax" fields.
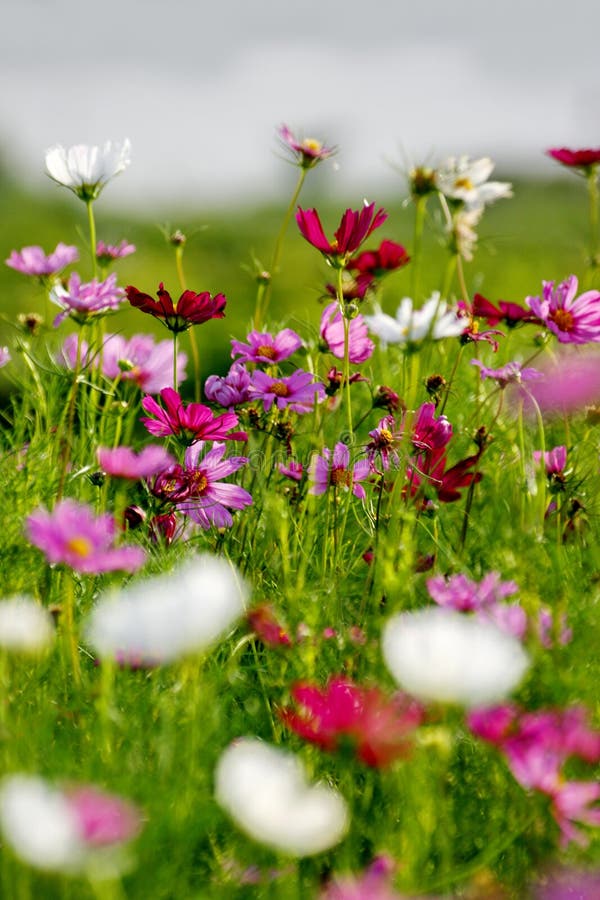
[{"xmin": 85, "ymin": 554, "xmax": 248, "ymax": 665}]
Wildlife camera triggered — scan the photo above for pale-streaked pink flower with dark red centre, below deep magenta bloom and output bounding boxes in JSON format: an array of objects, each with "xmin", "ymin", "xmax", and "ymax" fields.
[{"xmin": 172, "ymin": 443, "xmax": 252, "ymax": 530}]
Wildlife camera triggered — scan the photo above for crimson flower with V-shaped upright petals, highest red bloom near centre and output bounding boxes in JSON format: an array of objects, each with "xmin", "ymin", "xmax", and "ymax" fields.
[{"xmin": 296, "ymin": 203, "xmax": 387, "ymax": 268}]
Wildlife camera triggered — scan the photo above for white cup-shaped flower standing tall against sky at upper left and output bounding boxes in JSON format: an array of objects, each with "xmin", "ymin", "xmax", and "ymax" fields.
[{"xmin": 46, "ymin": 139, "xmax": 131, "ymax": 203}]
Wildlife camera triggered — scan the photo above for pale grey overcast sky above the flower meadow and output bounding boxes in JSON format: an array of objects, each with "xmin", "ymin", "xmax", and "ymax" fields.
[{"xmin": 0, "ymin": 0, "xmax": 600, "ymax": 204}]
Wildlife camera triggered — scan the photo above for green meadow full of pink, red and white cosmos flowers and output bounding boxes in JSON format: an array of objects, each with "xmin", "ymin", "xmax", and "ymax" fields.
[{"xmin": 0, "ymin": 132, "xmax": 600, "ymax": 900}]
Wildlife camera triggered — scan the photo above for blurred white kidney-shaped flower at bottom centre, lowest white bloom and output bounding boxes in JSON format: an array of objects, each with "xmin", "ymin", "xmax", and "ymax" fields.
[{"xmin": 215, "ymin": 738, "xmax": 349, "ymax": 856}]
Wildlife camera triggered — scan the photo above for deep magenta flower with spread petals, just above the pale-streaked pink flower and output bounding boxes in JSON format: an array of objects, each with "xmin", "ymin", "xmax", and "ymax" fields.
[{"xmin": 141, "ymin": 386, "xmax": 247, "ymax": 444}]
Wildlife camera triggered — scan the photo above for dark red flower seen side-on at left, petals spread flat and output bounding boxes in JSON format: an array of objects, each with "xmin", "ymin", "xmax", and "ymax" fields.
[{"xmin": 125, "ymin": 281, "xmax": 227, "ymax": 334}]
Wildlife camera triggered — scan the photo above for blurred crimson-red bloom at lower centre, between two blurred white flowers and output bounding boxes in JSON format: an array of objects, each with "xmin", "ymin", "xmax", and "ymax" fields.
[{"xmin": 280, "ymin": 677, "xmax": 423, "ymax": 767}]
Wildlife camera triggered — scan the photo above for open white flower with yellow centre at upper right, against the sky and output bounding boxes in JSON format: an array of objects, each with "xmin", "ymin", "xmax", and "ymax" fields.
[{"xmin": 435, "ymin": 156, "xmax": 512, "ymax": 209}]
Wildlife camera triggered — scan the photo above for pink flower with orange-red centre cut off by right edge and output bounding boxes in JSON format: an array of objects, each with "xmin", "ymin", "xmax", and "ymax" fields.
[{"xmin": 525, "ymin": 275, "xmax": 600, "ymax": 344}]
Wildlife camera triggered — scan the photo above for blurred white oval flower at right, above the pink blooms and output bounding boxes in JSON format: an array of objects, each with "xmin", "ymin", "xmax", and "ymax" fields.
[{"xmin": 382, "ymin": 607, "xmax": 529, "ymax": 707}]
